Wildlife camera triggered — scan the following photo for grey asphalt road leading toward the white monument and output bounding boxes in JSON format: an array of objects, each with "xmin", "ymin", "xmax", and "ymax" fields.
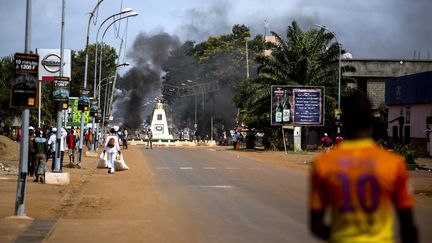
[{"xmin": 144, "ymin": 148, "xmax": 318, "ymax": 243}]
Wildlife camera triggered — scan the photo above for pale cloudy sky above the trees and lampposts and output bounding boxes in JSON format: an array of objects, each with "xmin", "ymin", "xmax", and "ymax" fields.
[{"xmin": 0, "ymin": 0, "xmax": 432, "ymax": 62}]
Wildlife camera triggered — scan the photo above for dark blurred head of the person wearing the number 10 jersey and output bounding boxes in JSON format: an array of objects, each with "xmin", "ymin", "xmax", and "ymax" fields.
[{"xmin": 341, "ymin": 91, "xmax": 372, "ymax": 129}]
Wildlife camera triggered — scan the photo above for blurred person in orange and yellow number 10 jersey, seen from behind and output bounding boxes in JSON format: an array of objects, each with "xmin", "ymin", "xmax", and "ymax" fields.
[{"xmin": 309, "ymin": 93, "xmax": 418, "ymax": 243}]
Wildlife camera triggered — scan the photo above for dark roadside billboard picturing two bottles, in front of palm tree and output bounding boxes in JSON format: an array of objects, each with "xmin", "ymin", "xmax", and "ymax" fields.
[{"xmin": 271, "ymin": 85, "xmax": 325, "ymax": 126}]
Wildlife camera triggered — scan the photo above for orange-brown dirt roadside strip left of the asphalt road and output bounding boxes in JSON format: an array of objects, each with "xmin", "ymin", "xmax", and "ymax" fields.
[{"xmin": 0, "ymin": 146, "xmax": 200, "ymax": 243}]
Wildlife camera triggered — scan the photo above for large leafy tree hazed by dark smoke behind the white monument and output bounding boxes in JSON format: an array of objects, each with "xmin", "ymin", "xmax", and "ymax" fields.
[{"xmin": 162, "ymin": 25, "xmax": 262, "ymax": 138}]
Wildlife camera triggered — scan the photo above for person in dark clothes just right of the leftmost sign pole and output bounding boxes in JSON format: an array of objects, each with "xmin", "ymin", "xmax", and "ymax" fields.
[{"xmin": 33, "ymin": 130, "xmax": 48, "ymax": 183}]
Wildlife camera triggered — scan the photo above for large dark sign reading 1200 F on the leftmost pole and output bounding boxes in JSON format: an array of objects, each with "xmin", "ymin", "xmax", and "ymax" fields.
[{"xmin": 10, "ymin": 53, "xmax": 39, "ymax": 108}]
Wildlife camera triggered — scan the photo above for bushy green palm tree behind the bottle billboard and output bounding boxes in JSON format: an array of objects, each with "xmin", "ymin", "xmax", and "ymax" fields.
[{"xmin": 235, "ymin": 21, "xmax": 353, "ymax": 147}]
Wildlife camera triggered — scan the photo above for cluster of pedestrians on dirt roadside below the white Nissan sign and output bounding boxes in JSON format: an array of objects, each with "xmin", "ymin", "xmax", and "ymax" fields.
[{"xmin": 28, "ymin": 126, "xmax": 80, "ymax": 183}]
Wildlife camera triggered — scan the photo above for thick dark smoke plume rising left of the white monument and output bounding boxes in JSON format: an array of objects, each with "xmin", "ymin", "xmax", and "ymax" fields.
[{"xmin": 116, "ymin": 32, "xmax": 180, "ymax": 129}]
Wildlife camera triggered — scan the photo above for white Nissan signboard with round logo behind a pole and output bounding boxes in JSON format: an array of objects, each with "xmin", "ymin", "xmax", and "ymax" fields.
[{"xmin": 36, "ymin": 48, "xmax": 71, "ymax": 80}]
